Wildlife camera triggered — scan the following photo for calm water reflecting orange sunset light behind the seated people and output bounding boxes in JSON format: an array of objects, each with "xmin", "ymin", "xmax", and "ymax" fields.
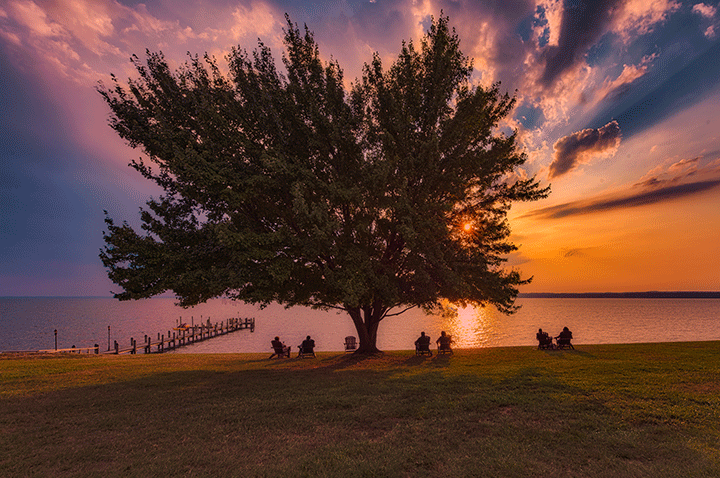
[{"xmin": 0, "ymin": 297, "xmax": 720, "ymax": 353}]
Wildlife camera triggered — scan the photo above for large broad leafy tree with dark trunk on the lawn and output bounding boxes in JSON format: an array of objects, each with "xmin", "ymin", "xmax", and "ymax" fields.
[{"xmin": 98, "ymin": 16, "xmax": 548, "ymax": 353}]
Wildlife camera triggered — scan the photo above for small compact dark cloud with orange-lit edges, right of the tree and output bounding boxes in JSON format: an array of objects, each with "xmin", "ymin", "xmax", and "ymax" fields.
[{"xmin": 548, "ymin": 121, "xmax": 622, "ymax": 178}]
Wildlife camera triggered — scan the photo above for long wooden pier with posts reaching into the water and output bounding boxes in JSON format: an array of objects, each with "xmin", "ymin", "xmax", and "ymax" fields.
[{"xmin": 39, "ymin": 317, "xmax": 255, "ymax": 355}]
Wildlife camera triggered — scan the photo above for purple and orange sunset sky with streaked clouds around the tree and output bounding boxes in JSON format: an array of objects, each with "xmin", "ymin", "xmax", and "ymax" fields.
[{"xmin": 0, "ymin": 0, "xmax": 720, "ymax": 296}]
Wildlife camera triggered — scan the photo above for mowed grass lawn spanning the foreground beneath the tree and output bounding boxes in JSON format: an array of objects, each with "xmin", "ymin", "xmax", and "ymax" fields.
[{"xmin": 0, "ymin": 342, "xmax": 720, "ymax": 478}]
